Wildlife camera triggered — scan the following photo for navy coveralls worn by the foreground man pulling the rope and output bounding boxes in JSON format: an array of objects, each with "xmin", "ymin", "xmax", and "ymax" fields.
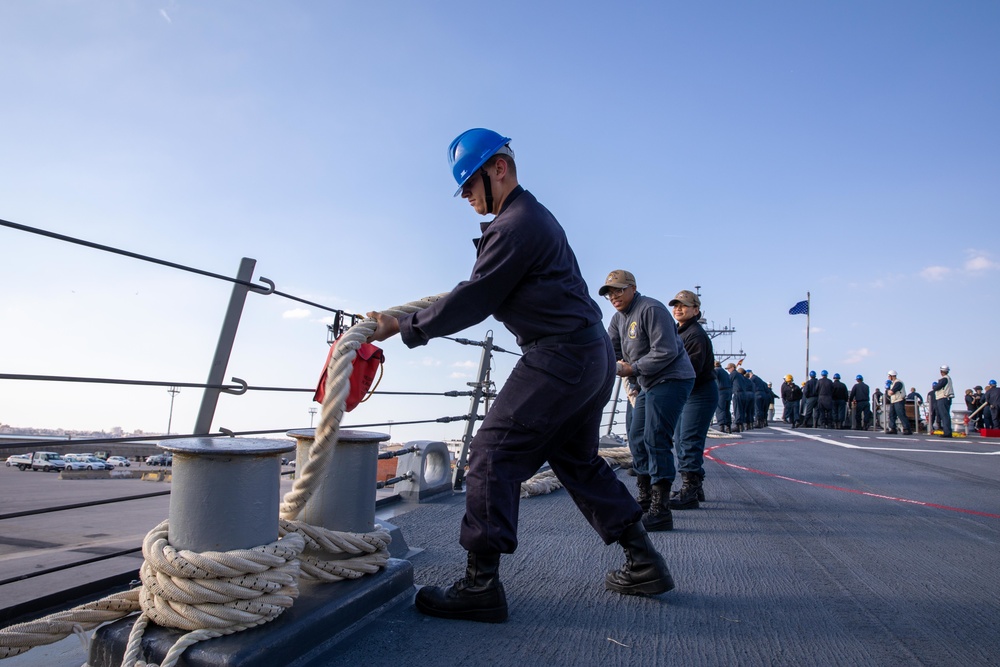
[{"xmin": 399, "ymin": 186, "xmax": 642, "ymax": 553}]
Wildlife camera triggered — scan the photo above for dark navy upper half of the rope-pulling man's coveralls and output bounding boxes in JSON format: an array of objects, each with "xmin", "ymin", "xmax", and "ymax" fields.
[{"xmin": 399, "ymin": 186, "xmax": 601, "ymax": 347}]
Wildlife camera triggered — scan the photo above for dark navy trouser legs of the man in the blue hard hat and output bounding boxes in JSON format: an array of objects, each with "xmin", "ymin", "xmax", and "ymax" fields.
[{"xmin": 460, "ymin": 336, "xmax": 642, "ymax": 553}]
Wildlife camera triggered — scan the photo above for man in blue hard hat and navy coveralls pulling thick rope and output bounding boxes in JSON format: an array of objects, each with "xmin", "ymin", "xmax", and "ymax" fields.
[{"xmin": 368, "ymin": 128, "xmax": 674, "ymax": 623}]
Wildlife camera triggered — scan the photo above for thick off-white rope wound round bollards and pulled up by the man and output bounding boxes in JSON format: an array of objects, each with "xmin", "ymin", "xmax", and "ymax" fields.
[{"xmin": 0, "ymin": 294, "xmax": 444, "ymax": 667}]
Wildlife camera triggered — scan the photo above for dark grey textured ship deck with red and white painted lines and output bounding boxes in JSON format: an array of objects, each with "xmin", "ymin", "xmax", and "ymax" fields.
[{"xmin": 324, "ymin": 428, "xmax": 1000, "ymax": 666}]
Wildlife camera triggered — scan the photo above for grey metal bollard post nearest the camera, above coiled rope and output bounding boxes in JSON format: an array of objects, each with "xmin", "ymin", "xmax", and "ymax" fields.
[{"xmin": 160, "ymin": 438, "xmax": 292, "ymax": 552}]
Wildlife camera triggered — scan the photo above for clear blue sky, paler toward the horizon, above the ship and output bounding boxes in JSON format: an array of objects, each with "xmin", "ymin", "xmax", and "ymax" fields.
[{"xmin": 0, "ymin": 0, "xmax": 1000, "ymax": 439}]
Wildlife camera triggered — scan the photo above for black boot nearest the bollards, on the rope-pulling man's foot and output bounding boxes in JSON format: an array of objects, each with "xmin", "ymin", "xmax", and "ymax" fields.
[{"xmin": 415, "ymin": 551, "xmax": 507, "ymax": 623}]
